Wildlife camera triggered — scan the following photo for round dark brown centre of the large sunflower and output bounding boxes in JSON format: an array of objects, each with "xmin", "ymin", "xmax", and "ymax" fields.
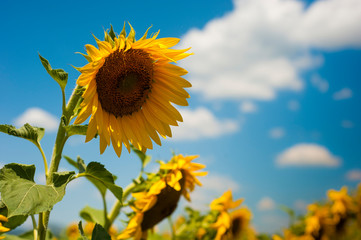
[{"xmin": 95, "ymin": 49, "xmax": 153, "ymax": 117}]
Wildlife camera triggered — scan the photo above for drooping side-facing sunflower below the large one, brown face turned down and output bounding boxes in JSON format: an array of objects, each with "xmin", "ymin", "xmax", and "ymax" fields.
[{"xmin": 118, "ymin": 155, "xmax": 207, "ymax": 240}]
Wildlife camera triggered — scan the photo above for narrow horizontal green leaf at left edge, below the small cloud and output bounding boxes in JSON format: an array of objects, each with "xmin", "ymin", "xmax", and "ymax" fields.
[{"xmin": 0, "ymin": 123, "xmax": 45, "ymax": 146}]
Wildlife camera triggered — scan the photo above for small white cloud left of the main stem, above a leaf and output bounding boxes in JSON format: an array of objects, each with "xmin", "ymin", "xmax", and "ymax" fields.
[{"xmin": 14, "ymin": 107, "xmax": 59, "ymax": 132}]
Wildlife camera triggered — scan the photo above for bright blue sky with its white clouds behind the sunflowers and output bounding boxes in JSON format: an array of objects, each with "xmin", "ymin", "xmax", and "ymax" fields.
[{"xmin": 0, "ymin": 0, "xmax": 361, "ymax": 232}]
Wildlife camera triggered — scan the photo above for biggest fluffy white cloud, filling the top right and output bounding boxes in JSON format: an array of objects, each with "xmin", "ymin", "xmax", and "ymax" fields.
[{"xmin": 182, "ymin": 0, "xmax": 361, "ymax": 100}]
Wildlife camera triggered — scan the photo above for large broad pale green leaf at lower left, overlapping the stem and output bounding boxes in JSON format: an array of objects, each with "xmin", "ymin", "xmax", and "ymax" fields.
[{"xmin": 0, "ymin": 163, "xmax": 75, "ymax": 218}]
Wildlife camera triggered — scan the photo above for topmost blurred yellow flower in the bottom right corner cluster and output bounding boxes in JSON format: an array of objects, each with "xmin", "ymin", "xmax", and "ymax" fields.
[{"xmin": 327, "ymin": 187, "xmax": 354, "ymax": 216}]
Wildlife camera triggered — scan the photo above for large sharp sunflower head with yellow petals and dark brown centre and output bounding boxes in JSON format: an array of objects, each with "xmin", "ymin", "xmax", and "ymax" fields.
[{"xmin": 75, "ymin": 23, "xmax": 191, "ymax": 156}]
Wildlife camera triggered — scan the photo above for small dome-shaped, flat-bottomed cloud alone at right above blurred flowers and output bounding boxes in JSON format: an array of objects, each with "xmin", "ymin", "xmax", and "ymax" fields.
[{"xmin": 276, "ymin": 143, "xmax": 341, "ymax": 167}]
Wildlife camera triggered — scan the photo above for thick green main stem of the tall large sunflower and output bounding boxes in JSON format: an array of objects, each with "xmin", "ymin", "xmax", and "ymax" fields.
[{"xmin": 38, "ymin": 86, "xmax": 81, "ymax": 240}]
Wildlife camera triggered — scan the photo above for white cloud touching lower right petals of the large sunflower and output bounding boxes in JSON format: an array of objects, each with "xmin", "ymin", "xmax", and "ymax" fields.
[{"xmin": 172, "ymin": 107, "xmax": 239, "ymax": 140}]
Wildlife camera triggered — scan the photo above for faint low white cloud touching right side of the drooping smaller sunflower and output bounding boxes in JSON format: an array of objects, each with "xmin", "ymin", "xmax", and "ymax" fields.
[{"xmin": 186, "ymin": 172, "xmax": 240, "ymax": 210}]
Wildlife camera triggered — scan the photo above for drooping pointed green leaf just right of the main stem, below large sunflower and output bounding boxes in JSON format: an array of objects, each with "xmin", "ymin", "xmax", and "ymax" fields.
[{"xmin": 78, "ymin": 162, "xmax": 123, "ymax": 201}]
